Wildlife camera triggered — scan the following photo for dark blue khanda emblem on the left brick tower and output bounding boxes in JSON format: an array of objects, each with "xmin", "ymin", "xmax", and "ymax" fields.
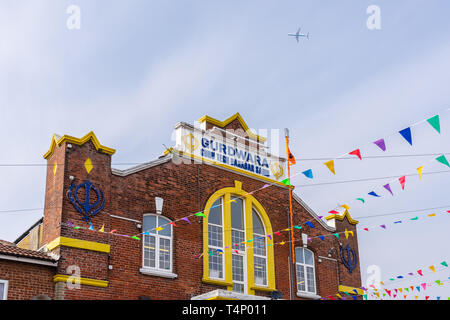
[{"xmin": 68, "ymin": 180, "xmax": 105, "ymax": 222}]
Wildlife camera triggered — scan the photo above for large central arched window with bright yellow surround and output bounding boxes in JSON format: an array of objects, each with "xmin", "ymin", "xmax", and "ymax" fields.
[{"xmin": 203, "ymin": 181, "xmax": 275, "ymax": 294}]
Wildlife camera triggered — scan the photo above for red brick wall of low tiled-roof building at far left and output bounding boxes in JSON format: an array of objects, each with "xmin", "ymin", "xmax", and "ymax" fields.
[{"xmin": 0, "ymin": 260, "xmax": 56, "ymax": 300}]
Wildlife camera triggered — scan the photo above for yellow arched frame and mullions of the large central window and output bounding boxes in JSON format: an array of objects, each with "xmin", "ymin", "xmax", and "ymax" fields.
[{"xmin": 202, "ymin": 181, "xmax": 276, "ymax": 294}]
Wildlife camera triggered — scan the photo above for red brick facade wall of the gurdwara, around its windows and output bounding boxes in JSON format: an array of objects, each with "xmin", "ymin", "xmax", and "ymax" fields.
[{"xmin": 39, "ymin": 135, "xmax": 360, "ymax": 299}]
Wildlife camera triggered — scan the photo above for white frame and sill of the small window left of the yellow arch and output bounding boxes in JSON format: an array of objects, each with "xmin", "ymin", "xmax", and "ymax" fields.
[{"xmin": 139, "ymin": 213, "xmax": 177, "ymax": 278}]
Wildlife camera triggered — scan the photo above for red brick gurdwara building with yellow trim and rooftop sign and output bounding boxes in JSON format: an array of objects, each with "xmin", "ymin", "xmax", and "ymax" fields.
[{"xmin": 0, "ymin": 113, "xmax": 362, "ymax": 300}]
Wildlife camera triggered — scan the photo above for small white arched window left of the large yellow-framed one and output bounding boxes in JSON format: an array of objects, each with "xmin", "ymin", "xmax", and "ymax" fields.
[{"xmin": 142, "ymin": 214, "xmax": 172, "ymax": 273}]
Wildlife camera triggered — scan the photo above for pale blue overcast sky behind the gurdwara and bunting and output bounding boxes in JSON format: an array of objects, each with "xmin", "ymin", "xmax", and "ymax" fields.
[{"xmin": 0, "ymin": 0, "xmax": 450, "ymax": 299}]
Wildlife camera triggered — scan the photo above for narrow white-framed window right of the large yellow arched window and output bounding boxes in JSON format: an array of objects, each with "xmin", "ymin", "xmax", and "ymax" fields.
[{"xmin": 295, "ymin": 248, "xmax": 316, "ymax": 294}]
